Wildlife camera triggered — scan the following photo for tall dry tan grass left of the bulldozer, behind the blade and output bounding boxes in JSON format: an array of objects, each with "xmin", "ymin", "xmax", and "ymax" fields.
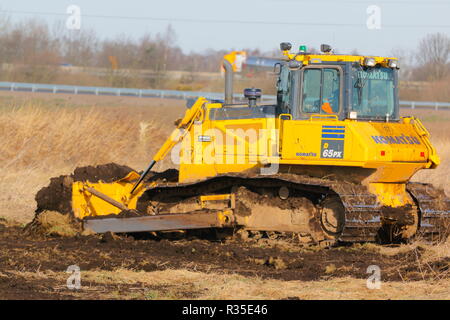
[{"xmin": 0, "ymin": 94, "xmax": 184, "ymax": 221}]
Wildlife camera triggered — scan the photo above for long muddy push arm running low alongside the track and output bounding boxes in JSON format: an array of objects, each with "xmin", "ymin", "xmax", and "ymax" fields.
[{"xmin": 83, "ymin": 212, "xmax": 236, "ymax": 233}]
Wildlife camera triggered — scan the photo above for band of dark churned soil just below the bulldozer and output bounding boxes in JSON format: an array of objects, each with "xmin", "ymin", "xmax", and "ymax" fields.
[{"xmin": 0, "ymin": 220, "xmax": 450, "ymax": 298}]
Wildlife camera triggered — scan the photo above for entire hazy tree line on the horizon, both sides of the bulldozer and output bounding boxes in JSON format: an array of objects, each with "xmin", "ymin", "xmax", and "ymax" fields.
[{"xmin": 0, "ymin": 17, "xmax": 450, "ymax": 81}]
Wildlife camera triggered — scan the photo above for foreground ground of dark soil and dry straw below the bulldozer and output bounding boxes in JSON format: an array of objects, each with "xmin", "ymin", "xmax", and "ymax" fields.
[{"xmin": 0, "ymin": 223, "xmax": 450, "ymax": 299}]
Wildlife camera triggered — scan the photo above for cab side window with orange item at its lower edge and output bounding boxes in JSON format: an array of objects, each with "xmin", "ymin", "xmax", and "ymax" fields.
[{"xmin": 302, "ymin": 68, "xmax": 340, "ymax": 114}]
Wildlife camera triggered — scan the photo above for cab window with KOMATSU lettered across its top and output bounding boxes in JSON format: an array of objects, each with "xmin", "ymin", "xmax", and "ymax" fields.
[{"xmin": 352, "ymin": 67, "xmax": 397, "ymax": 119}]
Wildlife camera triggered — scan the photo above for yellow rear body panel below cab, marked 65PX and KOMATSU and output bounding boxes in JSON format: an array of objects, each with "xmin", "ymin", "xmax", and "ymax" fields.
[{"xmin": 281, "ymin": 120, "xmax": 429, "ymax": 181}]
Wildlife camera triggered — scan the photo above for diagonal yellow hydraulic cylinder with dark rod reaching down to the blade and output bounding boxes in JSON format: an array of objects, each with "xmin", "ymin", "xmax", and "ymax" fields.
[{"xmin": 131, "ymin": 97, "xmax": 206, "ymax": 194}]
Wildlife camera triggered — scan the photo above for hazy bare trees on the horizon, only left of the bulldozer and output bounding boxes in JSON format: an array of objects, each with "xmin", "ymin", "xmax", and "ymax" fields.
[{"xmin": 0, "ymin": 18, "xmax": 268, "ymax": 72}]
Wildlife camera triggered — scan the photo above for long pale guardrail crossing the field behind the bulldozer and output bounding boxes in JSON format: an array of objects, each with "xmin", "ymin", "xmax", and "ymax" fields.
[{"xmin": 0, "ymin": 82, "xmax": 450, "ymax": 110}]
